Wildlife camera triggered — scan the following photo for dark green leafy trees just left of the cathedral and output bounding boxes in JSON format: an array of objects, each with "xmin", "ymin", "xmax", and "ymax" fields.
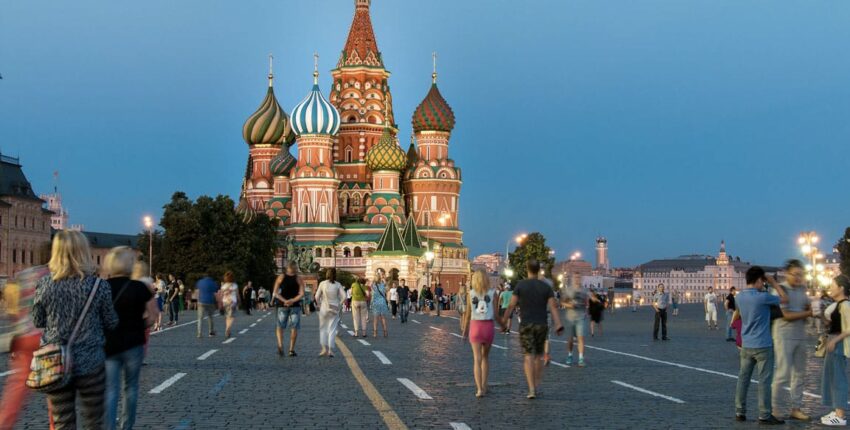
[{"xmin": 139, "ymin": 192, "xmax": 277, "ymax": 288}]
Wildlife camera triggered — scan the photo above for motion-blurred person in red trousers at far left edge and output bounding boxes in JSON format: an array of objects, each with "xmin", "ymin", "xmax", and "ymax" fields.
[{"xmin": 0, "ymin": 266, "xmax": 50, "ymax": 430}]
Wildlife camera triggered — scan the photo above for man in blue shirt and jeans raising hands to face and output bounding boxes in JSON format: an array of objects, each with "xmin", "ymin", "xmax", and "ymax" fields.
[{"xmin": 735, "ymin": 266, "xmax": 784, "ymax": 425}]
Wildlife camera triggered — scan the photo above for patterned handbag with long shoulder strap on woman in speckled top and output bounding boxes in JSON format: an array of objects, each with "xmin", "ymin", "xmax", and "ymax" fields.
[{"xmin": 26, "ymin": 278, "xmax": 100, "ymax": 393}]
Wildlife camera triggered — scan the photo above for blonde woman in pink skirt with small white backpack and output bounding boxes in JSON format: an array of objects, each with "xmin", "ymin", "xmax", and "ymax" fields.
[{"xmin": 461, "ymin": 270, "xmax": 496, "ymax": 398}]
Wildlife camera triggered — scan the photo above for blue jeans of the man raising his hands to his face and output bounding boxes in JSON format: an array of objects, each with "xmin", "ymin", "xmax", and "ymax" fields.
[{"xmin": 735, "ymin": 346, "xmax": 773, "ymax": 420}]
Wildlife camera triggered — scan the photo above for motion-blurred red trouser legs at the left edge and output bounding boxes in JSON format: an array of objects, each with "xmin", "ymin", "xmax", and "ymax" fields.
[{"xmin": 0, "ymin": 334, "xmax": 41, "ymax": 429}]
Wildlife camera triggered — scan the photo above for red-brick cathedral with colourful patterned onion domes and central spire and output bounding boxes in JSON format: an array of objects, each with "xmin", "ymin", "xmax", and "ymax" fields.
[{"xmin": 237, "ymin": 0, "xmax": 469, "ymax": 292}]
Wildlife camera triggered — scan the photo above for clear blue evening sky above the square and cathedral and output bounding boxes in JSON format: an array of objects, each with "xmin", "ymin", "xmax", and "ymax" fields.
[{"xmin": 0, "ymin": 0, "xmax": 850, "ymax": 266}]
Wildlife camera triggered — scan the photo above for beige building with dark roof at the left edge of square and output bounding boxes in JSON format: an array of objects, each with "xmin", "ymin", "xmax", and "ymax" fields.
[{"xmin": 0, "ymin": 155, "xmax": 53, "ymax": 283}]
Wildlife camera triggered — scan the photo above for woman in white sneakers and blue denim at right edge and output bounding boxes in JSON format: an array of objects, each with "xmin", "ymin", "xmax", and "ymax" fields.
[{"xmin": 820, "ymin": 275, "xmax": 850, "ymax": 426}]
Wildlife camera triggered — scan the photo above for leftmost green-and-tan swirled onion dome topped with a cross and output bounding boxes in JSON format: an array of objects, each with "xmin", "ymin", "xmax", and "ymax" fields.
[{"xmin": 242, "ymin": 56, "xmax": 294, "ymax": 145}]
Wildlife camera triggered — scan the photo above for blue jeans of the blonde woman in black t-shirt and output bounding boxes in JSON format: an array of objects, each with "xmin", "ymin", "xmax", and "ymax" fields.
[{"xmin": 104, "ymin": 345, "xmax": 145, "ymax": 430}]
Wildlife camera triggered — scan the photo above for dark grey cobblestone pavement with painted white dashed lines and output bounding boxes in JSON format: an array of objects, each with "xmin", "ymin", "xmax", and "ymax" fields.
[{"xmin": 0, "ymin": 305, "xmax": 840, "ymax": 429}]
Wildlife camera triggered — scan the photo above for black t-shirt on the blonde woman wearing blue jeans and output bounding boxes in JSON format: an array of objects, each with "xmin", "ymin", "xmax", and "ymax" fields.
[{"xmin": 101, "ymin": 277, "xmax": 153, "ymax": 357}]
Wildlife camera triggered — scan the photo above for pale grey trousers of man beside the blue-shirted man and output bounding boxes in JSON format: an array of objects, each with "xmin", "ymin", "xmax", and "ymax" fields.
[{"xmin": 771, "ymin": 331, "xmax": 808, "ymax": 411}]
